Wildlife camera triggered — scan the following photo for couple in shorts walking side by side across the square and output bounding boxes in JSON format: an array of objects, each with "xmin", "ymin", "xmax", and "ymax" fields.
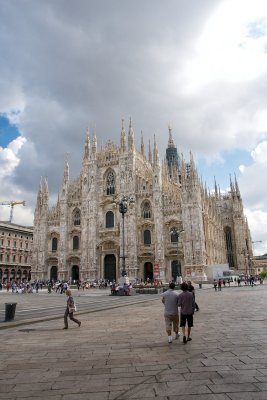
[{"xmin": 162, "ymin": 282, "xmax": 195, "ymax": 344}]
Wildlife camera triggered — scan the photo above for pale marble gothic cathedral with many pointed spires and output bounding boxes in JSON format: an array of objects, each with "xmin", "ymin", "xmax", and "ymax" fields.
[{"xmin": 32, "ymin": 121, "xmax": 252, "ymax": 282}]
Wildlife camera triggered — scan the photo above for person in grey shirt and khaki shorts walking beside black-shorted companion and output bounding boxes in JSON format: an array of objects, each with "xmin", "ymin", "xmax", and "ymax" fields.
[{"xmin": 161, "ymin": 282, "xmax": 180, "ymax": 343}]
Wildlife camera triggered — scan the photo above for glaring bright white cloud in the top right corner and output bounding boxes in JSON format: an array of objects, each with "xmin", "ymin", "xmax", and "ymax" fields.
[{"xmin": 185, "ymin": 0, "xmax": 267, "ymax": 91}]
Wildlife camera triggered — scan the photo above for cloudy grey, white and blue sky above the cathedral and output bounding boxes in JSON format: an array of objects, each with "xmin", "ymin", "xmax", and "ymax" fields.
[{"xmin": 0, "ymin": 0, "xmax": 267, "ymax": 254}]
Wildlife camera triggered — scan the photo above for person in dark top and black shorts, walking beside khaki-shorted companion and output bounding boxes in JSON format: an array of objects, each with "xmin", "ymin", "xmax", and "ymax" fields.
[{"xmin": 178, "ymin": 282, "xmax": 195, "ymax": 344}]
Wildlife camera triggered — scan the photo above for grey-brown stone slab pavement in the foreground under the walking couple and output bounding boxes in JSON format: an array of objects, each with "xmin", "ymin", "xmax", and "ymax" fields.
[{"xmin": 0, "ymin": 286, "xmax": 267, "ymax": 400}]
